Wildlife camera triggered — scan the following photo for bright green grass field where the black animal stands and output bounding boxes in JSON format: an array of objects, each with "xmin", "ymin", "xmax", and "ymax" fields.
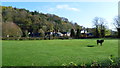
[{"xmin": 2, "ymin": 39, "xmax": 118, "ymax": 66}]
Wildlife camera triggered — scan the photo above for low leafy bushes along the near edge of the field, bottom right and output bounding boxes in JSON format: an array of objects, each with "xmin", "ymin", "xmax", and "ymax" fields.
[{"xmin": 62, "ymin": 57, "xmax": 120, "ymax": 68}]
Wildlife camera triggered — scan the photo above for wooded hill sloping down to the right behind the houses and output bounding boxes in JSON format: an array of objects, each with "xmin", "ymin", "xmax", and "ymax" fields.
[{"xmin": 1, "ymin": 6, "xmax": 82, "ymax": 37}]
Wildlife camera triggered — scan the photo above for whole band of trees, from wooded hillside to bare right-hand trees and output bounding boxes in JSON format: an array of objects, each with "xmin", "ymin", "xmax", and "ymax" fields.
[{"xmin": 1, "ymin": 6, "xmax": 120, "ymax": 38}]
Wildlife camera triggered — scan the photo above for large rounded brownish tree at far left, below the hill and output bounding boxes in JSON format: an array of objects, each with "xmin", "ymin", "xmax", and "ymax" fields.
[{"xmin": 2, "ymin": 22, "xmax": 22, "ymax": 37}]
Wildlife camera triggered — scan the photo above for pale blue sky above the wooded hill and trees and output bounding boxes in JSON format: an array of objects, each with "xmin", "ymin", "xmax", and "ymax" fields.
[{"xmin": 2, "ymin": 2, "xmax": 118, "ymax": 30}]
